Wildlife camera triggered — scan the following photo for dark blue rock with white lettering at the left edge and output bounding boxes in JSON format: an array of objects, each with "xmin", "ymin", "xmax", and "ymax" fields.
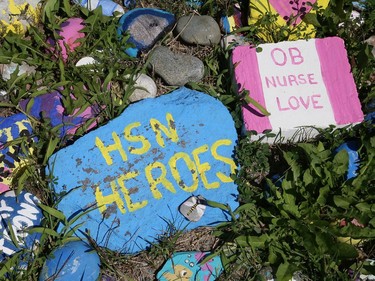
[{"xmin": 0, "ymin": 190, "xmax": 43, "ymax": 262}]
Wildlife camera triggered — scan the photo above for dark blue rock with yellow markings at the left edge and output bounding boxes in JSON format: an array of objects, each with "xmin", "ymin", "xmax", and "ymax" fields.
[{"xmin": 0, "ymin": 113, "xmax": 33, "ymax": 191}]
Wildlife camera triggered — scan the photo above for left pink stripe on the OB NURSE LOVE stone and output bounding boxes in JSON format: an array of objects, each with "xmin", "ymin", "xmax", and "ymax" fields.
[{"xmin": 232, "ymin": 46, "xmax": 272, "ymax": 133}]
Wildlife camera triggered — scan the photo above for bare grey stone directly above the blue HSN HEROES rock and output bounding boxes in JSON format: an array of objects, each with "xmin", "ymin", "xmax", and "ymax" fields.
[{"xmin": 149, "ymin": 46, "xmax": 204, "ymax": 86}]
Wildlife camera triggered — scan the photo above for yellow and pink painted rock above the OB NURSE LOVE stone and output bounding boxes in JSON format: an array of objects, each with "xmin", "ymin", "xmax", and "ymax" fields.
[{"xmin": 249, "ymin": 0, "xmax": 329, "ymax": 42}]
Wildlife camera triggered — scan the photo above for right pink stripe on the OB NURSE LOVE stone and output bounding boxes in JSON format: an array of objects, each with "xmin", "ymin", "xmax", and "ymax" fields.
[{"xmin": 315, "ymin": 37, "xmax": 363, "ymax": 125}]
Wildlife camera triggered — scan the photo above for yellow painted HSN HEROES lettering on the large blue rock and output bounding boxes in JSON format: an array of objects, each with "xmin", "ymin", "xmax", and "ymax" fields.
[{"xmin": 95, "ymin": 113, "xmax": 236, "ymax": 214}]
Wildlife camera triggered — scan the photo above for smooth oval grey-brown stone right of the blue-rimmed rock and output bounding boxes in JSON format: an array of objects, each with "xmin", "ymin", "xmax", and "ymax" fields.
[{"xmin": 176, "ymin": 15, "xmax": 221, "ymax": 45}]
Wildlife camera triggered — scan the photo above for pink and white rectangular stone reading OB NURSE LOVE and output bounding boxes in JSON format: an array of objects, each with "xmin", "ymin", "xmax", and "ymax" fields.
[{"xmin": 232, "ymin": 37, "xmax": 363, "ymax": 138}]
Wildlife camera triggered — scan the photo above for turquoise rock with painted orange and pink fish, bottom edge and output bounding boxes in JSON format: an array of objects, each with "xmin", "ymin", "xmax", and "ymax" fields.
[{"xmin": 156, "ymin": 252, "xmax": 224, "ymax": 281}]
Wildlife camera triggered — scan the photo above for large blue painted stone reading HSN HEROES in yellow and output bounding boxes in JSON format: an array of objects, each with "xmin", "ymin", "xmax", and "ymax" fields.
[{"xmin": 46, "ymin": 88, "xmax": 238, "ymax": 252}]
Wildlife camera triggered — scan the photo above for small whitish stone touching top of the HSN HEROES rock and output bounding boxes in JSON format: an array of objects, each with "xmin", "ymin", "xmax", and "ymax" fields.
[{"xmin": 129, "ymin": 73, "xmax": 158, "ymax": 102}]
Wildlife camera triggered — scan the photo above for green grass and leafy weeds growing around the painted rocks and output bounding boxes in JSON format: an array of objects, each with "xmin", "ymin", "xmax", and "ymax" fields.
[{"xmin": 0, "ymin": 0, "xmax": 375, "ymax": 280}]
